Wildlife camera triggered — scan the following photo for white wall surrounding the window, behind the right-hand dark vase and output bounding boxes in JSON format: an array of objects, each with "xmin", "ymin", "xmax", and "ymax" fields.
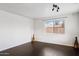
[{"xmin": 35, "ymin": 14, "xmax": 79, "ymax": 46}]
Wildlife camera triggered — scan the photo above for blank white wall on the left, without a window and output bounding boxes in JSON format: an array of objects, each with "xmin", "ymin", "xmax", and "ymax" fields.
[{"xmin": 0, "ymin": 11, "xmax": 33, "ymax": 51}]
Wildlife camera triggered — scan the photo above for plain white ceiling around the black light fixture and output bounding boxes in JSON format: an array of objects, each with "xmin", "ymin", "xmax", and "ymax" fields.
[{"xmin": 0, "ymin": 3, "xmax": 79, "ymax": 18}]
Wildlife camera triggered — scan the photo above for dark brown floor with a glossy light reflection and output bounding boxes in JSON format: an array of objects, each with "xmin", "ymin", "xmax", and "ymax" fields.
[{"xmin": 0, "ymin": 42, "xmax": 79, "ymax": 56}]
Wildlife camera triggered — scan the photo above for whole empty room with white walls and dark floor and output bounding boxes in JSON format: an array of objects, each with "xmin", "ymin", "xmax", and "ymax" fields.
[{"xmin": 0, "ymin": 3, "xmax": 79, "ymax": 56}]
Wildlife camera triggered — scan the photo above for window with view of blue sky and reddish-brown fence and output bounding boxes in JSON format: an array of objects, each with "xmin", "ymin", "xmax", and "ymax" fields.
[{"xmin": 45, "ymin": 19, "xmax": 64, "ymax": 33}]
